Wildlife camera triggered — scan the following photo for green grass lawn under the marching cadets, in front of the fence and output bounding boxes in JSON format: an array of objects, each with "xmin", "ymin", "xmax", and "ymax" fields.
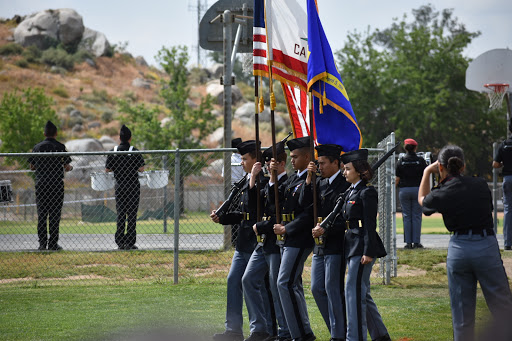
[{"xmin": 0, "ymin": 250, "xmax": 512, "ymax": 341}]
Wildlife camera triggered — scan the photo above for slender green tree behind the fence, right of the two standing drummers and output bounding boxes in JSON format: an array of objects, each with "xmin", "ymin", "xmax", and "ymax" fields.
[{"xmin": 119, "ymin": 46, "xmax": 219, "ymax": 211}]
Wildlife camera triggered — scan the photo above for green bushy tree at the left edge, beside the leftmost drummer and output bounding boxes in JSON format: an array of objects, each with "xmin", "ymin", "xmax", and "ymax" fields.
[{"xmin": 0, "ymin": 88, "xmax": 58, "ymax": 153}]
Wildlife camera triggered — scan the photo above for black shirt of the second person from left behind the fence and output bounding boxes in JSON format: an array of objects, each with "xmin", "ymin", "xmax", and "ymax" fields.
[{"xmin": 105, "ymin": 142, "xmax": 144, "ymax": 186}]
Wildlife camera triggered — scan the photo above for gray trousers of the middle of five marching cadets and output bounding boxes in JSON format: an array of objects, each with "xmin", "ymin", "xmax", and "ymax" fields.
[{"xmin": 277, "ymin": 246, "xmax": 313, "ymax": 339}]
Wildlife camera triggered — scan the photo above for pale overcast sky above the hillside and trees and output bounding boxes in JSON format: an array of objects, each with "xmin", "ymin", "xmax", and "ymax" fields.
[{"xmin": 0, "ymin": 0, "xmax": 512, "ymax": 69}]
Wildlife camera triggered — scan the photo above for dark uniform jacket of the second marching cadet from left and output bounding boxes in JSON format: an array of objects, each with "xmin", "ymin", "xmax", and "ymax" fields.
[{"xmin": 256, "ymin": 174, "xmax": 288, "ymax": 254}]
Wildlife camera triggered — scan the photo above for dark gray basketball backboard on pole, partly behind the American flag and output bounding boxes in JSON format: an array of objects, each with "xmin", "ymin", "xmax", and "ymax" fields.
[{"xmin": 199, "ymin": 0, "xmax": 254, "ymax": 53}]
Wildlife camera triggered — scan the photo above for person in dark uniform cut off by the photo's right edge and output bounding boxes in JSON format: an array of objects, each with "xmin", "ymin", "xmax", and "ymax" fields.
[{"xmin": 492, "ymin": 121, "xmax": 512, "ymax": 250}]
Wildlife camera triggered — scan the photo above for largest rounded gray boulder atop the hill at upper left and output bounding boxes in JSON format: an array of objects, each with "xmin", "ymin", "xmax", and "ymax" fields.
[{"xmin": 14, "ymin": 8, "xmax": 84, "ymax": 50}]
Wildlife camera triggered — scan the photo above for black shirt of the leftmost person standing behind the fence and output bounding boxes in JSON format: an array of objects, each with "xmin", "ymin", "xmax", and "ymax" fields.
[{"xmin": 28, "ymin": 137, "xmax": 71, "ymax": 183}]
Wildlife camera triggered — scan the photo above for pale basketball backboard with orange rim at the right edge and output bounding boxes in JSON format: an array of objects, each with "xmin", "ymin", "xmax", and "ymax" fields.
[{"xmin": 466, "ymin": 49, "xmax": 512, "ymax": 93}]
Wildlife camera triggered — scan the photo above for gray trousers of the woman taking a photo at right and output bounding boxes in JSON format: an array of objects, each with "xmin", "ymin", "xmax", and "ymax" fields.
[{"xmin": 446, "ymin": 233, "xmax": 512, "ymax": 341}]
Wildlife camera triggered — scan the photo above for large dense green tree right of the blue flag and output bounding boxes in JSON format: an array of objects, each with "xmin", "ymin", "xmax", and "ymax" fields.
[{"xmin": 337, "ymin": 5, "xmax": 506, "ymax": 175}]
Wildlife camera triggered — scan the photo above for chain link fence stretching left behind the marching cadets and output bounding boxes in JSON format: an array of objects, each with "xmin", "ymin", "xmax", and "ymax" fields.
[{"xmin": 0, "ymin": 137, "xmax": 394, "ymax": 285}]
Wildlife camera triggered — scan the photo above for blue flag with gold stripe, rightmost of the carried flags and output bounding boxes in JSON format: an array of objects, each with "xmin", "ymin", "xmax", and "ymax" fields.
[{"xmin": 308, "ymin": 0, "xmax": 363, "ymax": 152}]
